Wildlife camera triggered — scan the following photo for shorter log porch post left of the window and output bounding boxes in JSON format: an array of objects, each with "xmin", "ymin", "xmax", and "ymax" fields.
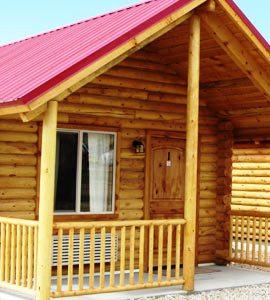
[{"xmin": 37, "ymin": 101, "xmax": 58, "ymax": 300}]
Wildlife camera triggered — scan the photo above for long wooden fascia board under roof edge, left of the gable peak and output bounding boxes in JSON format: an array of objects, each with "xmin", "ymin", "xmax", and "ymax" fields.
[{"xmin": 14, "ymin": 0, "xmax": 207, "ymax": 114}]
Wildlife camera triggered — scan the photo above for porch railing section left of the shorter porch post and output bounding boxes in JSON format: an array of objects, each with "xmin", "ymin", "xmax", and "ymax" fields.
[{"xmin": 0, "ymin": 217, "xmax": 38, "ymax": 292}]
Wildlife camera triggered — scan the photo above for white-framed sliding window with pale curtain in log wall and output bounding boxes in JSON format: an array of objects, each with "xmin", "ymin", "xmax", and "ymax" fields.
[{"xmin": 54, "ymin": 130, "xmax": 116, "ymax": 214}]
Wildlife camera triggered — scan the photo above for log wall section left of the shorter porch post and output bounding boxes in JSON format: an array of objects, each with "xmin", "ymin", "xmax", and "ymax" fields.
[{"xmin": 0, "ymin": 118, "xmax": 38, "ymax": 219}]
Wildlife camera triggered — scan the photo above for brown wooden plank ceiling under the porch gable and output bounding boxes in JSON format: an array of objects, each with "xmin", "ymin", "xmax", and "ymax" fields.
[{"xmin": 145, "ymin": 1, "xmax": 270, "ymax": 132}]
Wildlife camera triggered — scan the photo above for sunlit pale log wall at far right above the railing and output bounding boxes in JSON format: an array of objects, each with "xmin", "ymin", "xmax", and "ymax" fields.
[{"xmin": 231, "ymin": 142, "xmax": 270, "ymax": 213}]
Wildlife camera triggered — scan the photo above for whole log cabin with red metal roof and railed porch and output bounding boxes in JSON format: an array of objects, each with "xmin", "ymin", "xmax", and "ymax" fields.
[{"xmin": 0, "ymin": 0, "xmax": 270, "ymax": 300}]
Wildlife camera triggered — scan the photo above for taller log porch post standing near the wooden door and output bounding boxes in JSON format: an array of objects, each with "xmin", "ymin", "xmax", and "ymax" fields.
[{"xmin": 183, "ymin": 15, "xmax": 200, "ymax": 291}]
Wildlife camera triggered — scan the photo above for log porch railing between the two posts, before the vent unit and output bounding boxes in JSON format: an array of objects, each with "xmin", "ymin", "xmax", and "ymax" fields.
[{"xmin": 52, "ymin": 219, "xmax": 186, "ymax": 297}]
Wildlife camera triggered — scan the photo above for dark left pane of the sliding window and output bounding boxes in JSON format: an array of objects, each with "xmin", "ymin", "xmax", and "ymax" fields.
[{"xmin": 54, "ymin": 132, "xmax": 78, "ymax": 212}]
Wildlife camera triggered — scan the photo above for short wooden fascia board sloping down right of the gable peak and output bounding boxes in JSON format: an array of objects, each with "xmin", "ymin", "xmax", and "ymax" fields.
[{"xmin": 216, "ymin": 0, "xmax": 270, "ymax": 63}]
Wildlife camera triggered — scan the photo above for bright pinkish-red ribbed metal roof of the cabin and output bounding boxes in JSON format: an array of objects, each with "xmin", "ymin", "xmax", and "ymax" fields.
[{"xmin": 0, "ymin": 0, "xmax": 269, "ymax": 106}]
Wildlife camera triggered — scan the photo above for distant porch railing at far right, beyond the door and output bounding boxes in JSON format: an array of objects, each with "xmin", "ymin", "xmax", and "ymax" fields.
[{"xmin": 229, "ymin": 212, "xmax": 270, "ymax": 267}]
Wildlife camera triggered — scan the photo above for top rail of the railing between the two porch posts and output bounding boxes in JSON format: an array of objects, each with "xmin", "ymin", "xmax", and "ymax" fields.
[{"xmin": 54, "ymin": 219, "xmax": 186, "ymax": 229}]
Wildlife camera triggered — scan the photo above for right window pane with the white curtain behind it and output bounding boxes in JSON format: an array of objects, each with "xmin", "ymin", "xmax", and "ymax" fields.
[{"xmin": 81, "ymin": 132, "xmax": 114, "ymax": 213}]
